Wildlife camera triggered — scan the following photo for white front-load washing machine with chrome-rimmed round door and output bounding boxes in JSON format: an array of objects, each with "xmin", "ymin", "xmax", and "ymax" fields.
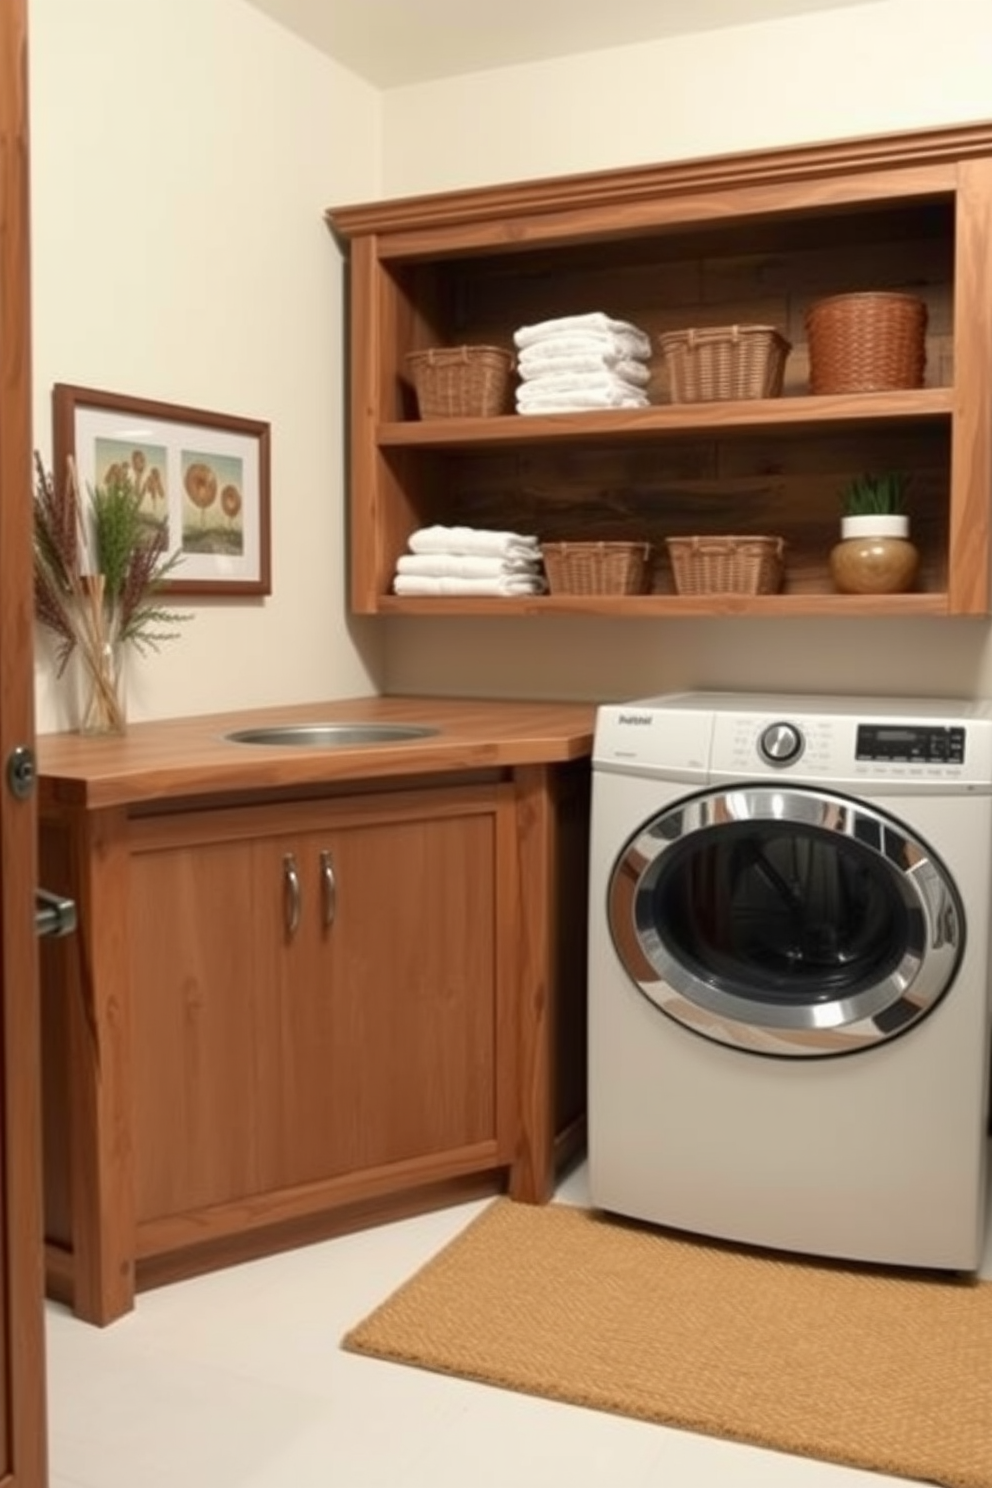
[{"xmin": 589, "ymin": 693, "xmax": 992, "ymax": 1271}]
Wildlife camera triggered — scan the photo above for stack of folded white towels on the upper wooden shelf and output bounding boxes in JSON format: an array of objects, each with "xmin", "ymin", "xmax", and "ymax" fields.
[{"xmin": 513, "ymin": 310, "xmax": 651, "ymax": 414}]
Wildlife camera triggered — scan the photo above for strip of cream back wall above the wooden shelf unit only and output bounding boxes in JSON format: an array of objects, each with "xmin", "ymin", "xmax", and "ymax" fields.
[{"xmin": 382, "ymin": 0, "xmax": 992, "ymax": 196}]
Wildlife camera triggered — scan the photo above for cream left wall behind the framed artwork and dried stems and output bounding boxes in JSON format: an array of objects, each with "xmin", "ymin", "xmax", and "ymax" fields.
[{"xmin": 30, "ymin": 0, "xmax": 382, "ymax": 731}]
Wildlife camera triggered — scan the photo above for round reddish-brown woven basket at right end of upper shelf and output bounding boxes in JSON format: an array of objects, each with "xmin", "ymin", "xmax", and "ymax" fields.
[{"xmin": 806, "ymin": 293, "xmax": 927, "ymax": 393}]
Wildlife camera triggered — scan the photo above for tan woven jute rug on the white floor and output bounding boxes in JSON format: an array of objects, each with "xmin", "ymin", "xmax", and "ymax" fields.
[{"xmin": 342, "ymin": 1199, "xmax": 992, "ymax": 1488}]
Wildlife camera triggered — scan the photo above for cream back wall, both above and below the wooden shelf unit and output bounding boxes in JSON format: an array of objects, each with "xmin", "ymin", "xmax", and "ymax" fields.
[{"xmin": 376, "ymin": 0, "xmax": 992, "ymax": 699}]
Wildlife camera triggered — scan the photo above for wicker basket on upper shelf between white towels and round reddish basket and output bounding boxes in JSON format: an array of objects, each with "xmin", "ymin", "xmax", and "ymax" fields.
[{"xmin": 657, "ymin": 326, "xmax": 791, "ymax": 403}]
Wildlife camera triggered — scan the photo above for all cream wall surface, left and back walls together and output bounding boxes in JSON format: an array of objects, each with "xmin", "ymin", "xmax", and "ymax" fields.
[{"xmin": 30, "ymin": 0, "xmax": 992, "ymax": 729}]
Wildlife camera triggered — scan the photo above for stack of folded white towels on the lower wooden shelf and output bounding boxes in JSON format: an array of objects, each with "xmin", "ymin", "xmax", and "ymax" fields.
[{"xmin": 393, "ymin": 527, "xmax": 547, "ymax": 595}]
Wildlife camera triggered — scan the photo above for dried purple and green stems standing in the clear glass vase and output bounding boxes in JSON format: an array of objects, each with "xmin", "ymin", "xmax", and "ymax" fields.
[{"xmin": 34, "ymin": 452, "xmax": 189, "ymax": 728}]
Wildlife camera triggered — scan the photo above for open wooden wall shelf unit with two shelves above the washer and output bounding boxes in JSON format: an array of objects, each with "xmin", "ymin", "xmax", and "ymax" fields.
[{"xmin": 327, "ymin": 126, "xmax": 992, "ymax": 616}]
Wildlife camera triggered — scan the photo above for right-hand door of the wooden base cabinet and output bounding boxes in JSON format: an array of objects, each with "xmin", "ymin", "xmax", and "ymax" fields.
[{"xmin": 256, "ymin": 787, "xmax": 513, "ymax": 1187}]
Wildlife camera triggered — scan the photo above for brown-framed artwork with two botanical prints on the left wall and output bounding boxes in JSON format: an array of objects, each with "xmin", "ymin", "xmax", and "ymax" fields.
[{"xmin": 52, "ymin": 382, "xmax": 272, "ymax": 594}]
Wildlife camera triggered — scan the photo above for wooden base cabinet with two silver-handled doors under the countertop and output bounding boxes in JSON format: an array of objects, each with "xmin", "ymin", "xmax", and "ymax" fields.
[{"xmin": 40, "ymin": 726, "xmax": 589, "ymax": 1323}]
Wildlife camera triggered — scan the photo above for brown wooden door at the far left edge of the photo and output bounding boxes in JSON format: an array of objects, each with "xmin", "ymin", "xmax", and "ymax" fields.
[{"xmin": 0, "ymin": 0, "xmax": 46, "ymax": 1488}]
